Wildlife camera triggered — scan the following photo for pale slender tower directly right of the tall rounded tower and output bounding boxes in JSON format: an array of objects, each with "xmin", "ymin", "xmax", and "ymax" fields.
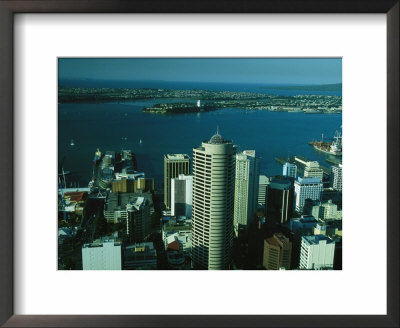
[{"xmin": 233, "ymin": 150, "xmax": 260, "ymax": 235}]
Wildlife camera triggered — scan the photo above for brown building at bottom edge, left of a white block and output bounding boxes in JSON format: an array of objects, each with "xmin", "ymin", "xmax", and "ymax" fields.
[{"xmin": 263, "ymin": 233, "xmax": 292, "ymax": 270}]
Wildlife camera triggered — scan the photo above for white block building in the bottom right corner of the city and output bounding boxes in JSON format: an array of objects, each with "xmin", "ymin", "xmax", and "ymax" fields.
[{"xmin": 299, "ymin": 235, "xmax": 335, "ymax": 270}]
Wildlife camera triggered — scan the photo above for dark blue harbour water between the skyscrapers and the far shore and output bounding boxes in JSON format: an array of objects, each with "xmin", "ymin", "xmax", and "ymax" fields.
[{"xmin": 58, "ymin": 100, "xmax": 342, "ymax": 187}]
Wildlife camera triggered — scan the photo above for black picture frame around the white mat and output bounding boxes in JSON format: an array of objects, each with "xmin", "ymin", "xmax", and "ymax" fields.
[{"xmin": 0, "ymin": 0, "xmax": 400, "ymax": 327}]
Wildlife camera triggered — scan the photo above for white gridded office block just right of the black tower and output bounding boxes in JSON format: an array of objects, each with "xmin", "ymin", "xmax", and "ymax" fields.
[{"xmin": 294, "ymin": 177, "xmax": 323, "ymax": 213}]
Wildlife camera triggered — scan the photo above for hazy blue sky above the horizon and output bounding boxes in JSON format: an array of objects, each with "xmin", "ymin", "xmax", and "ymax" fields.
[{"xmin": 58, "ymin": 58, "xmax": 342, "ymax": 84}]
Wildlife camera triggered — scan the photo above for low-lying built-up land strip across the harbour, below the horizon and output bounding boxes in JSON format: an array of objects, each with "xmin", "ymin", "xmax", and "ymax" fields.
[{"xmin": 58, "ymin": 87, "xmax": 342, "ymax": 114}]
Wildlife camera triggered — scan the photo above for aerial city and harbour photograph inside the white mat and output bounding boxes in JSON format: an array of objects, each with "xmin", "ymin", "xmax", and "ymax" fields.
[{"xmin": 57, "ymin": 58, "xmax": 343, "ymax": 270}]
